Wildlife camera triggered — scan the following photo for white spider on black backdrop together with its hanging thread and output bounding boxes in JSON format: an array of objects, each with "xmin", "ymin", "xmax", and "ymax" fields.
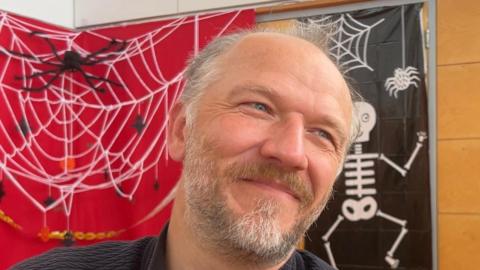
[{"xmin": 385, "ymin": 6, "xmax": 420, "ymax": 98}]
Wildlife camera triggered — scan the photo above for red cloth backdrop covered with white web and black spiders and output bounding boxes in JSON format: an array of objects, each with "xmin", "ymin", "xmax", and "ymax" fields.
[{"xmin": 0, "ymin": 10, "xmax": 254, "ymax": 269}]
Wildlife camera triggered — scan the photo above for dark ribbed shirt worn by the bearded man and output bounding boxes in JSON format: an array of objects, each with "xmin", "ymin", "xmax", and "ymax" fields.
[{"xmin": 11, "ymin": 226, "xmax": 334, "ymax": 270}]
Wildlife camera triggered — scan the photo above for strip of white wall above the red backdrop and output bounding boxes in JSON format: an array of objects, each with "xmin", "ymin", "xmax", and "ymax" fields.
[{"xmin": 0, "ymin": 0, "xmax": 291, "ymax": 28}]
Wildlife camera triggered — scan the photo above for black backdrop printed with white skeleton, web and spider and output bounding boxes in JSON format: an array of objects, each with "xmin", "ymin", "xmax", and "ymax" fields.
[{"xmin": 300, "ymin": 4, "xmax": 432, "ymax": 270}]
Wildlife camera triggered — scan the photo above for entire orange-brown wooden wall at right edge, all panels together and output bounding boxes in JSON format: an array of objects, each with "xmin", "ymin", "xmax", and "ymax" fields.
[{"xmin": 437, "ymin": 0, "xmax": 480, "ymax": 270}]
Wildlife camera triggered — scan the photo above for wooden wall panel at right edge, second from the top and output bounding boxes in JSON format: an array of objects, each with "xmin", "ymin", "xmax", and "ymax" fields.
[{"xmin": 438, "ymin": 63, "xmax": 480, "ymax": 139}]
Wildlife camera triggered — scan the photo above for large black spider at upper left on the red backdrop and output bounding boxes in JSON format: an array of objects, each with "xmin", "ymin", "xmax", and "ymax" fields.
[{"xmin": 8, "ymin": 32, "xmax": 127, "ymax": 93}]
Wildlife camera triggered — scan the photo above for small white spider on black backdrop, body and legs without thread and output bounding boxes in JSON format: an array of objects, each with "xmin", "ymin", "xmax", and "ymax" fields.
[{"xmin": 385, "ymin": 67, "xmax": 420, "ymax": 98}]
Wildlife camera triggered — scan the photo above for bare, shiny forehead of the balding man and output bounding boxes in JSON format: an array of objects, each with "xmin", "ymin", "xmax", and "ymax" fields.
[{"xmin": 216, "ymin": 32, "xmax": 350, "ymax": 101}]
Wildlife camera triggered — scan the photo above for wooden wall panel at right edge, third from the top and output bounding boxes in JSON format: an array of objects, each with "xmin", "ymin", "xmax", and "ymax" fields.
[{"xmin": 438, "ymin": 139, "xmax": 480, "ymax": 213}]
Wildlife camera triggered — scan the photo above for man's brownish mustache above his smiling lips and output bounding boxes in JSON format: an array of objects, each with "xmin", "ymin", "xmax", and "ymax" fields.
[{"xmin": 224, "ymin": 162, "xmax": 314, "ymax": 207}]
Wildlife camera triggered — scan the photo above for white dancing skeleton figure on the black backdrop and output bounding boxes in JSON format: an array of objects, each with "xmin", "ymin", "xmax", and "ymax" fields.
[{"xmin": 322, "ymin": 102, "xmax": 427, "ymax": 269}]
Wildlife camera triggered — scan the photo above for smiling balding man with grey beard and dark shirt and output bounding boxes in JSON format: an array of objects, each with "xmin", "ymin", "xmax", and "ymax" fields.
[{"xmin": 12, "ymin": 22, "xmax": 359, "ymax": 270}]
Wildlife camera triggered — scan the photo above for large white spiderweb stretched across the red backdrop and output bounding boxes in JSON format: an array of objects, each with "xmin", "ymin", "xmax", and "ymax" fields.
[{"xmin": 0, "ymin": 11, "xmax": 240, "ymax": 221}]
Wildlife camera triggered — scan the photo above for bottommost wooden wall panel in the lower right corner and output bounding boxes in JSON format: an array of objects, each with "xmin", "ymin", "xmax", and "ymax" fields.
[{"xmin": 439, "ymin": 214, "xmax": 480, "ymax": 270}]
